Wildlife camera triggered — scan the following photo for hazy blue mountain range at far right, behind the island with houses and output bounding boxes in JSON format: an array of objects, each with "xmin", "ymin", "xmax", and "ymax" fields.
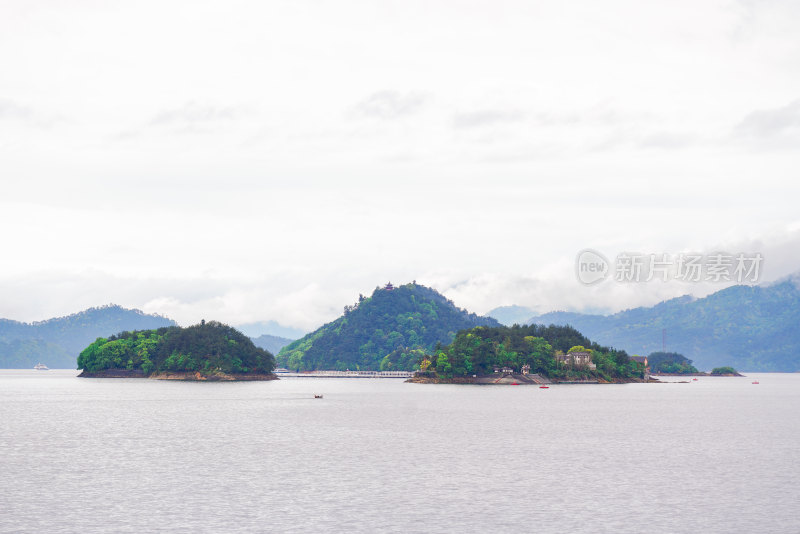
[{"xmin": 525, "ymin": 281, "xmax": 800, "ymax": 372}]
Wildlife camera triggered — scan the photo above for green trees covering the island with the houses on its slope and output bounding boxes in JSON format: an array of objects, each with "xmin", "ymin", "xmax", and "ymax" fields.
[{"xmin": 420, "ymin": 325, "xmax": 644, "ymax": 380}]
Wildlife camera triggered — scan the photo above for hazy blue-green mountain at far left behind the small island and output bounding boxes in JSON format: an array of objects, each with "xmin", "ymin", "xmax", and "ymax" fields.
[{"xmin": 0, "ymin": 305, "xmax": 175, "ymax": 369}]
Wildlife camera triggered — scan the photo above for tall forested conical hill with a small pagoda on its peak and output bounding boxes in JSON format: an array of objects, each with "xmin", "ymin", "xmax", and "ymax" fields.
[{"xmin": 277, "ymin": 283, "xmax": 498, "ymax": 371}]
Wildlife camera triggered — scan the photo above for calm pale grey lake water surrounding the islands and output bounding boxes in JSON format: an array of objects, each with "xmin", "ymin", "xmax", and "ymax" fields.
[{"xmin": 0, "ymin": 370, "xmax": 800, "ymax": 533}]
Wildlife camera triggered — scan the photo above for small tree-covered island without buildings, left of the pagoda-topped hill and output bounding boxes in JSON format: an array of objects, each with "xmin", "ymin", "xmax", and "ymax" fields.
[{"xmin": 78, "ymin": 321, "xmax": 277, "ymax": 381}]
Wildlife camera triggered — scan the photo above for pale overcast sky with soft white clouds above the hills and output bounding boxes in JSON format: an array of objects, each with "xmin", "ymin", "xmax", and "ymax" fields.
[{"xmin": 0, "ymin": 0, "xmax": 800, "ymax": 329}]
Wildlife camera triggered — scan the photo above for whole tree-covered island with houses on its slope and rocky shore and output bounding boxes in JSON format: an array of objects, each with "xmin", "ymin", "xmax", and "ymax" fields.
[{"xmin": 411, "ymin": 325, "xmax": 648, "ymax": 383}]
